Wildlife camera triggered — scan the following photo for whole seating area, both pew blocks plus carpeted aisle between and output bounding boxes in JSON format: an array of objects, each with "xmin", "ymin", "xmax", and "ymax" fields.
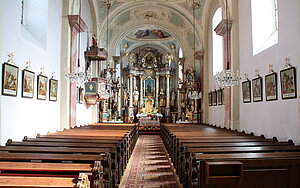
[{"xmin": 0, "ymin": 123, "xmax": 300, "ymax": 188}]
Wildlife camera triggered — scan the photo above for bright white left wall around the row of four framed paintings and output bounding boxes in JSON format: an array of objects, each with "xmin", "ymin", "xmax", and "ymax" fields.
[{"xmin": 0, "ymin": 0, "xmax": 63, "ymax": 144}]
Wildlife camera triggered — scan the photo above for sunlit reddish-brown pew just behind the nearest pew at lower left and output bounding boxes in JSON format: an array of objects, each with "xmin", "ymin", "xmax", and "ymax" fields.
[{"xmin": 0, "ymin": 161, "xmax": 104, "ymax": 187}]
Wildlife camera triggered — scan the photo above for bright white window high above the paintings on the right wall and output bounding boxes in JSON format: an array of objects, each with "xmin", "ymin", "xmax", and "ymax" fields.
[{"xmin": 251, "ymin": 0, "xmax": 278, "ymax": 55}]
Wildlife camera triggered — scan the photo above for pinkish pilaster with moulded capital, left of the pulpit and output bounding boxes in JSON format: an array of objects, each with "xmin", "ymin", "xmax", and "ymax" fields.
[{"xmin": 68, "ymin": 15, "xmax": 87, "ymax": 127}]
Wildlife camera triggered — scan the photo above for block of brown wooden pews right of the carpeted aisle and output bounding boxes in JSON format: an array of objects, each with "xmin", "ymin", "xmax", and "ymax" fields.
[{"xmin": 161, "ymin": 125, "xmax": 300, "ymax": 187}]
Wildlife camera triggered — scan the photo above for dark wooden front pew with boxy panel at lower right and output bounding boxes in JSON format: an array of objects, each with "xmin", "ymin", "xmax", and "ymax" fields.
[{"xmin": 195, "ymin": 152, "xmax": 300, "ymax": 188}]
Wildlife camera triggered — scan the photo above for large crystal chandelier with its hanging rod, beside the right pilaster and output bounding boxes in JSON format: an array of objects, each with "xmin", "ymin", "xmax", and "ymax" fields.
[{"xmin": 215, "ymin": 0, "xmax": 241, "ymax": 88}]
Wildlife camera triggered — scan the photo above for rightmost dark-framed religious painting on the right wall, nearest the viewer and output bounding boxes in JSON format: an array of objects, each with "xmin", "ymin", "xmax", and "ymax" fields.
[{"xmin": 280, "ymin": 67, "xmax": 297, "ymax": 99}]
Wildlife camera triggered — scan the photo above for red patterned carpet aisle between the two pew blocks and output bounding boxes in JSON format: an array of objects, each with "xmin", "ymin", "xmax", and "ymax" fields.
[{"xmin": 120, "ymin": 135, "xmax": 182, "ymax": 188}]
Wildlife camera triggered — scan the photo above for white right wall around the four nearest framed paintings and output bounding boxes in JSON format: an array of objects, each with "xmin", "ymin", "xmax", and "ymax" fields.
[{"xmin": 239, "ymin": 0, "xmax": 300, "ymax": 144}]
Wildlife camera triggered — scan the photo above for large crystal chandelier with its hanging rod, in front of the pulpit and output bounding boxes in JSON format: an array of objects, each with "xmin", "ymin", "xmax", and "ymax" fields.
[{"xmin": 65, "ymin": 1, "xmax": 92, "ymax": 87}]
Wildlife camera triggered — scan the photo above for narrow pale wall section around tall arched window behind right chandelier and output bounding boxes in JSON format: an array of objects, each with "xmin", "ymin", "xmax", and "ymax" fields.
[{"xmin": 207, "ymin": 0, "xmax": 224, "ymax": 127}]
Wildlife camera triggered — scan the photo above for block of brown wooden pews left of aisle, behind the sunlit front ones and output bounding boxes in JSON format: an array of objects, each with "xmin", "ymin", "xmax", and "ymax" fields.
[{"xmin": 0, "ymin": 122, "xmax": 137, "ymax": 187}]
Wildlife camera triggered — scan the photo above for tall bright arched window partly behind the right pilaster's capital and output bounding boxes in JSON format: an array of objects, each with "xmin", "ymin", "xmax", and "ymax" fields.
[{"xmin": 212, "ymin": 8, "xmax": 223, "ymax": 75}]
